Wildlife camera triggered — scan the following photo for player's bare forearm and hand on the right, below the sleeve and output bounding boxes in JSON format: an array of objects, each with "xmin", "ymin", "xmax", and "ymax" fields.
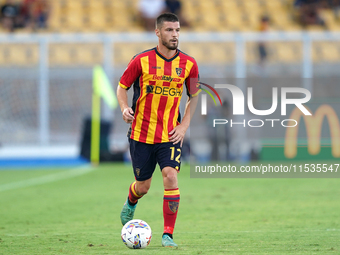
[{"xmin": 169, "ymin": 96, "xmax": 198, "ymax": 147}]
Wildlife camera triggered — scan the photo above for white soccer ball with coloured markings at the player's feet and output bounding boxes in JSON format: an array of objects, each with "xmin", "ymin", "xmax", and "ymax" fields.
[{"xmin": 121, "ymin": 220, "xmax": 152, "ymax": 249}]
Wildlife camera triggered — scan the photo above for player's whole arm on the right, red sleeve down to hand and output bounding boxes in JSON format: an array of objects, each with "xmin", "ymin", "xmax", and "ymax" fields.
[{"xmin": 169, "ymin": 59, "xmax": 201, "ymax": 147}]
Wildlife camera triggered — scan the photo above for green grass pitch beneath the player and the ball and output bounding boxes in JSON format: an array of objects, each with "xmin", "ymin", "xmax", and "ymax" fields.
[{"xmin": 0, "ymin": 164, "xmax": 340, "ymax": 255}]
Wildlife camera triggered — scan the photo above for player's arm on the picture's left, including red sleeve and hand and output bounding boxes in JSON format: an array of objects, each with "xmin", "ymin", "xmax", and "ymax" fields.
[{"xmin": 117, "ymin": 57, "xmax": 142, "ymax": 123}]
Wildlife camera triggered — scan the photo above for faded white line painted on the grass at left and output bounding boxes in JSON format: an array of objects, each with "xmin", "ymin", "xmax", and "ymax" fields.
[{"xmin": 0, "ymin": 165, "xmax": 95, "ymax": 192}]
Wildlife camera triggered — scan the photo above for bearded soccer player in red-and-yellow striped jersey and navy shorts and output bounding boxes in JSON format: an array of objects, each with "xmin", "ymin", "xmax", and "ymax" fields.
[{"xmin": 117, "ymin": 13, "xmax": 201, "ymax": 247}]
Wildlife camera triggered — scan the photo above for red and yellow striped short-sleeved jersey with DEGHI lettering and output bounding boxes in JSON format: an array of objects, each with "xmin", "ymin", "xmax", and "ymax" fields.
[{"xmin": 119, "ymin": 47, "xmax": 200, "ymax": 144}]
